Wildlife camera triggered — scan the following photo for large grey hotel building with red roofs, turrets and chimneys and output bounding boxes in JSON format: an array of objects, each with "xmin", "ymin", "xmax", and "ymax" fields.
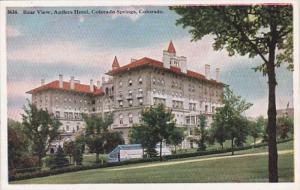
[{"xmin": 28, "ymin": 41, "xmax": 224, "ymax": 148}]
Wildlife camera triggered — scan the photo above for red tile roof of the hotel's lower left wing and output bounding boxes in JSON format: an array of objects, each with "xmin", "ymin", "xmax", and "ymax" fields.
[{"xmin": 26, "ymin": 80, "xmax": 104, "ymax": 95}]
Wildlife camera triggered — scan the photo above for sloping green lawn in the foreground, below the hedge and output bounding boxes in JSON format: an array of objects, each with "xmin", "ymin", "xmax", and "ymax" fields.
[{"xmin": 13, "ymin": 141, "xmax": 294, "ymax": 184}]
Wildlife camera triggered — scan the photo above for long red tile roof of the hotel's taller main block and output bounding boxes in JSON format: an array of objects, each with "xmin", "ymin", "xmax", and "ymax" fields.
[{"xmin": 106, "ymin": 57, "xmax": 223, "ymax": 85}]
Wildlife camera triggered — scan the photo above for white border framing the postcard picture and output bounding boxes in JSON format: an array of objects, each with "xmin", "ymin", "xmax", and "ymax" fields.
[{"xmin": 0, "ymin": 0, "xmax": 300, "ymax": 190}]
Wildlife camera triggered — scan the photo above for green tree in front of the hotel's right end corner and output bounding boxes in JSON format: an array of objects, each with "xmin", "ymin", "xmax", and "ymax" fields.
[{"xmin": 212, "ymin": 87, "xmax": 252, "ymax": 155}]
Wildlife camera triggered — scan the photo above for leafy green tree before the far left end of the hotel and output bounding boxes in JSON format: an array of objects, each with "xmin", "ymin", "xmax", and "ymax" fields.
[{"xmin": 22, "ymin": 101, "xmax": 61, "ymax": 166}]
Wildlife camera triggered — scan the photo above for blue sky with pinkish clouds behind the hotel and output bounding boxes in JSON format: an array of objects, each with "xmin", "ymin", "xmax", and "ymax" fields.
[{"xmin": 6, "ymin": 6, "xmax": 293, "ymax": 120}]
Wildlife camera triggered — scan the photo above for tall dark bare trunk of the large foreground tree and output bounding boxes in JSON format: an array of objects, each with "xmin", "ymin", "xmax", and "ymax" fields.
[{"xmin": 267, "ymin": 43, "xmax": 278, "ymax": 182}]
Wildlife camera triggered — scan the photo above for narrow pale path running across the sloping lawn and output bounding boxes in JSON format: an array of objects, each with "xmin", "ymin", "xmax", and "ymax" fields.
[{"xmin": 107, "ymin": 149, "xmax": 294, "ymax": 171}]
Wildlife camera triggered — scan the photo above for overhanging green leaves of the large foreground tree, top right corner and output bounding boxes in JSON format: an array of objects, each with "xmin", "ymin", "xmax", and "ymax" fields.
[{"xmin": 171, "ymin": 5, "xmax": 293, "ymax": 70}]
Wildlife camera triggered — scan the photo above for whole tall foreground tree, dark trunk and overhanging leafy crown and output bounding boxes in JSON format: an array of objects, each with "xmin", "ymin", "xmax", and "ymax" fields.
[{"xmin": 171, "ymin": 5, "xmax": 293, "ymax": 182}]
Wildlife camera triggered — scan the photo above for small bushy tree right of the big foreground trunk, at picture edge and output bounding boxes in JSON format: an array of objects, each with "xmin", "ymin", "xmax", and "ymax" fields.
[{"xmin": 277, "ymin": 116, "xmax": 294, "ymax": 139}]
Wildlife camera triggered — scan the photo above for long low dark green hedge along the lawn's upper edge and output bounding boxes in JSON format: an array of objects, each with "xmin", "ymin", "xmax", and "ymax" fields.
[{"xmin": 9, "ymin": 139, "xmax": 293, "ymax": 181}]
